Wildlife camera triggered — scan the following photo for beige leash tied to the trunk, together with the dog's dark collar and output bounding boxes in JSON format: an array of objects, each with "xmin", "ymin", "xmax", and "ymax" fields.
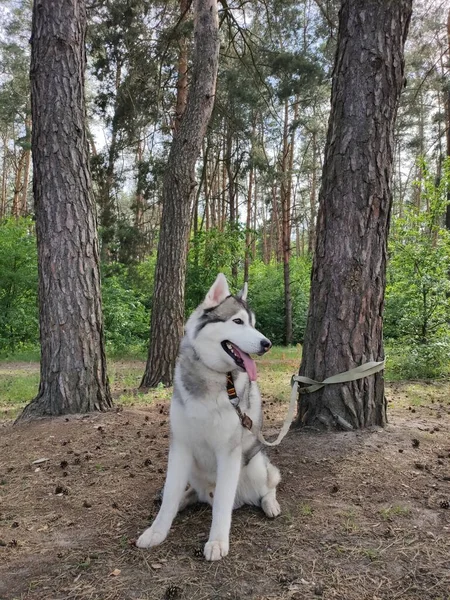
[{"xmin": 227, "ymin": 360, "xmax": 386, "ymax": 446}]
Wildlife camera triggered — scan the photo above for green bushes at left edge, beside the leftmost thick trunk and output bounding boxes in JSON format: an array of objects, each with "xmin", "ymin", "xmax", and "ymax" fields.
[{"xmin": 0, "ymin": 218, "xmax": 39, "ymax": 354}]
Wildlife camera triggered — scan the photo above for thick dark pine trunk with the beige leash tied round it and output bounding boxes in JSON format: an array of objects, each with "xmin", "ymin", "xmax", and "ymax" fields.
[{"xmin": 297, "ymin": 0, "xmax": 412, "ymax": 429}]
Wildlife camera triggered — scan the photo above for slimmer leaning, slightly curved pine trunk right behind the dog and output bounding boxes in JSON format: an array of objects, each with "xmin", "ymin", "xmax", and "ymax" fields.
[{"xmin": 141, "ymin": 0, "xmax": 219, "ymax": 388}]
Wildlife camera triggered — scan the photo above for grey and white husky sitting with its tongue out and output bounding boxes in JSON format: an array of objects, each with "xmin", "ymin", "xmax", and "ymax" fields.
[{"xmin": 136, "ymin": 273, "xmax": 280, "ymax": 560}]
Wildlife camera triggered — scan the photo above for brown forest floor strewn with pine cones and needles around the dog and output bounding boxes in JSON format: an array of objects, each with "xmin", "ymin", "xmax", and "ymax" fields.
[{"xmin": 0, "ymin": 351, "xmax": 450, "ymax": 600}]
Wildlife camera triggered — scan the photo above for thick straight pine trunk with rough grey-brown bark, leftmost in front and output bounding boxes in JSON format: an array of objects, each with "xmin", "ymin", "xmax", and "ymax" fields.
[{"xmin": 20, "ymin": 0, "xmax": 112, "ymax": 420}]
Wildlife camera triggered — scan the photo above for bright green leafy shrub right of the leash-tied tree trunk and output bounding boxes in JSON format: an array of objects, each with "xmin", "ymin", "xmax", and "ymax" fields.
[{"xmin": 385, "ymin": 157, "xmax": 450, "ymax": 377}]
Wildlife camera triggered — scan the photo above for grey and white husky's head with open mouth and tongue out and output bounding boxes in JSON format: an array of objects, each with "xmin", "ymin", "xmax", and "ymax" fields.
[{"xmin": 186, "ymin": 273, "xmax": 272, "ymax": 381}]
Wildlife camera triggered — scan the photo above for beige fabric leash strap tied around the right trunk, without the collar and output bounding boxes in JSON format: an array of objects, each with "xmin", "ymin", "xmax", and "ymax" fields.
[{"xmin": 255, "ymin": 360, "xmax": 386, "ymax": 446}]
